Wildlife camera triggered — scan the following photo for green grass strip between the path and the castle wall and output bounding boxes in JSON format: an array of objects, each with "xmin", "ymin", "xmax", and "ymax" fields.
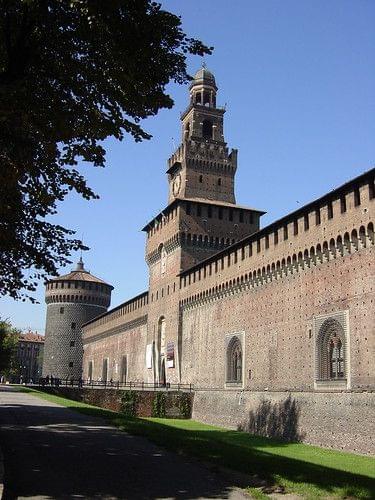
[{"xmin": 18, "ymin": 389, "xmax": 375, "ymax": 499}]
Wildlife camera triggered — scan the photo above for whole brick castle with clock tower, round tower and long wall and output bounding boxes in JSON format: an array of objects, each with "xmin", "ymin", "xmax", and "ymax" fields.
[{"xmin": 44, "ymin": 68, "xmax": 375, "ymax": 453}]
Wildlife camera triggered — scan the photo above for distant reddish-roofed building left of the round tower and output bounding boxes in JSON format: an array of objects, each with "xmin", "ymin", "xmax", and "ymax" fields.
[{"xmin": 17, "ymin": 331, "xmax": 44, "ymax": 382}]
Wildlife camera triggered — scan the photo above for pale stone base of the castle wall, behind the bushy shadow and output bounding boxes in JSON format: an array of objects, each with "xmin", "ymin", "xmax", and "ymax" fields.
[{"xmin": 193, "ymin": 390, "xmax": 375, "ymax": 455}]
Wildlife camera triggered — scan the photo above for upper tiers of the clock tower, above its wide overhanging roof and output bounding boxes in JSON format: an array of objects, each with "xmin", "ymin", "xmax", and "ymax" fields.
[{"xmin": 167, "ymin": 67, "xmax": 237, "ymax": 204}]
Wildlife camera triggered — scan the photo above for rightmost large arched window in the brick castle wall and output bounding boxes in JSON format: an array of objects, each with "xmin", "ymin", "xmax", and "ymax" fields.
[{"xmin": 317, "ymin": 318, "xmax": 346, "ymax": 380}]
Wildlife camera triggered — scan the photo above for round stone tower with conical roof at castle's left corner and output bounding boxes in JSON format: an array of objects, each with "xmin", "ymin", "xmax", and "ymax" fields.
[{"xmin": 43, "ymin": 258, "xmax": 113, "ymax": 379}]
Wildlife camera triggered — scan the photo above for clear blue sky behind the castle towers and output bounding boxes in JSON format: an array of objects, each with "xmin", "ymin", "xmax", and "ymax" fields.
[{"xmin": 0, "ymin": 0, "xmax": 375, "ymax": 333}]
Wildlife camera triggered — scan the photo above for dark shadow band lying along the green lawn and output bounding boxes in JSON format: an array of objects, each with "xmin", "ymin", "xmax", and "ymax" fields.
[{"xmin": 63, "ymin": 407, "xmax": 375, "ymax": 498}]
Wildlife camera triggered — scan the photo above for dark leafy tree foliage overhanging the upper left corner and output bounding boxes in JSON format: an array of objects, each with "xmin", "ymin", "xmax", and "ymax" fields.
[{"xmin": 0, "ymin": 0, "xmax": 211, "ymax": 300}]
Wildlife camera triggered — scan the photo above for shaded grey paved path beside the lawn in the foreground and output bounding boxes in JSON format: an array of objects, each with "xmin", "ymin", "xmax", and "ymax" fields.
[{"xmin": 0, "ymin": 387, "xmax": 250, "ymax": 500}]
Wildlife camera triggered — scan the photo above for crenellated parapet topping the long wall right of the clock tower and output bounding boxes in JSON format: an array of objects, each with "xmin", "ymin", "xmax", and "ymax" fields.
[{"xmin": 180, "ymin": 169, "xmax": 375, "ymax": 307}]
